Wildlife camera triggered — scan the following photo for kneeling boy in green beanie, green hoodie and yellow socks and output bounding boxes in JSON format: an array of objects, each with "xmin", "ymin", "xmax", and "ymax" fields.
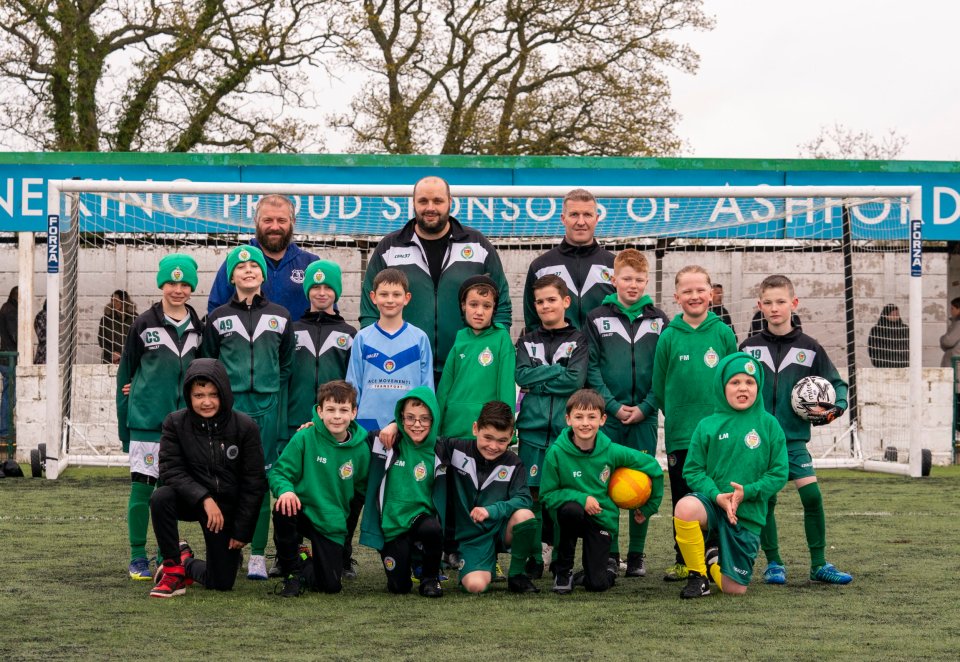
[{"xmin": 673, "ymin": 352, "xmax": 787, "ymax": 598}]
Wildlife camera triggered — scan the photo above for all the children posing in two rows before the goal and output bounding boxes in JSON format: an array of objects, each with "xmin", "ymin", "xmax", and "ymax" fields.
[{"xmin": 117, "ymin": 236, "xmax": 852, "ymax": 598}]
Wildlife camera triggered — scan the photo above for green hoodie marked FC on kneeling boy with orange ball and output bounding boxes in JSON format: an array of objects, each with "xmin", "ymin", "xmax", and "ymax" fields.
[{"xmin": 540, "ymin": 428, "xmax": 663, "ymax": 540}]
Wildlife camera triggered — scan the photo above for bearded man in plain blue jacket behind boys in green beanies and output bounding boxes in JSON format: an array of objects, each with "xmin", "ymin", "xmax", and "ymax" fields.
[{"xmin": 207, "ymin": 195, "xmax": 319, "ymax": 321}]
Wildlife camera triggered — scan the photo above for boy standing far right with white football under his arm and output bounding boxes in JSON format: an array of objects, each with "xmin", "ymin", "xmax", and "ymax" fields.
[{"xmin": 740, "ymin": 275, "xmax": 853, "ymax": 584}]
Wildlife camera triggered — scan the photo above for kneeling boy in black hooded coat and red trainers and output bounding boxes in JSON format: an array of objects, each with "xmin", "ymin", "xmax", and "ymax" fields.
[{"xmin": 150, "ymin": 359, "xmax": 267, "ymax": 598}]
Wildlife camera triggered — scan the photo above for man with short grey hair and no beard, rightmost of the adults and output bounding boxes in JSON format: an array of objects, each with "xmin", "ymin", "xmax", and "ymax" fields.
[{"xmin": 523, "ymin": 188, "xmax": 615, "ymax": 330}]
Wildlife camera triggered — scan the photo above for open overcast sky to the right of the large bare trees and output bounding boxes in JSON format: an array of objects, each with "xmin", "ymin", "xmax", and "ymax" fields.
[{"xmin": 671, "ymin": 0, "xmax": 960, "ymax": 161}]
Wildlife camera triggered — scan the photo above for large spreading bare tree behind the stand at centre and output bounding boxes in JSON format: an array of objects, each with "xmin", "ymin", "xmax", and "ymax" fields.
[{"xmin": 336, "ymin": 0, "xmax": 712, "ymax": 155}]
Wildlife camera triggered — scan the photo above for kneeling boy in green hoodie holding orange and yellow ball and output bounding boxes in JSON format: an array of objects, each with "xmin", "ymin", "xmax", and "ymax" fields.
[{"xmin": 540, "ymin": 389, "xmax": 663, "ymax": 595}]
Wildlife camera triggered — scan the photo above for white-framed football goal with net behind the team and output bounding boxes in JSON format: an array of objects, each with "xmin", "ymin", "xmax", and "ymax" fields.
[{"xmin": 44, "ymin": 180, "xmax": 922, "ymax": 477}]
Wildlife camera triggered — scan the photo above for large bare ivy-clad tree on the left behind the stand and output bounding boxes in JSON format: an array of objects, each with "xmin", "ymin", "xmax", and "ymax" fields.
[{"xmin": 0, "ymin": 0, "xmax": 340, "ymax": 151}]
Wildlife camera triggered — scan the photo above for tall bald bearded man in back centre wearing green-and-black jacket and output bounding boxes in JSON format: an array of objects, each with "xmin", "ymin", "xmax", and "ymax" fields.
[{"xmin": 360, "ymin": 177, "xmax": 513, "ymax": 382}]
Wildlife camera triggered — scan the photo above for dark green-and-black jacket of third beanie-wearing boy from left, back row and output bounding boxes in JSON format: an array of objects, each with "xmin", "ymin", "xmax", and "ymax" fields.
[{"xmin": 286, "ymin": 311, "xmax": 357, "ymax": 439}]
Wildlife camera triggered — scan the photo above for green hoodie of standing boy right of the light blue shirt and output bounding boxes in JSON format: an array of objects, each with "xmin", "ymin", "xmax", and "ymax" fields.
[{"xmin": 437, "ymin": 324, "xmax": 517, "ymax": 438}]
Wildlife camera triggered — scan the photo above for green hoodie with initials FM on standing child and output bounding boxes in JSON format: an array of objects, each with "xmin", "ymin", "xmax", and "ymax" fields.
[{"xmin": 653, "ymin": 312, "xmax": 737, "ymax": 453}]
